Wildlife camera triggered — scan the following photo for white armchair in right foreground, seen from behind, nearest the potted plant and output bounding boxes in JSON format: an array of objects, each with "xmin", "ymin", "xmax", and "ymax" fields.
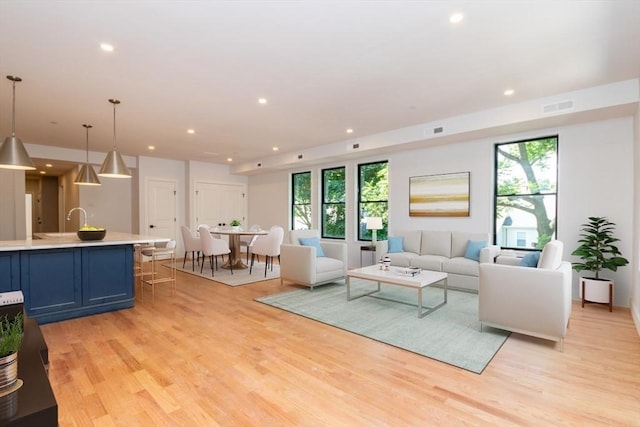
[{"xmin": 478, "ymin": 240, "xmax": 571, "ymax": 349}]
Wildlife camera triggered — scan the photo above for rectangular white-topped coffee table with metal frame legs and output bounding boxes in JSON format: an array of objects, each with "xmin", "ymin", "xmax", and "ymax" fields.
[{"xmin": 345, "ymin": 265, "xmax": 447, "ymax": 318}]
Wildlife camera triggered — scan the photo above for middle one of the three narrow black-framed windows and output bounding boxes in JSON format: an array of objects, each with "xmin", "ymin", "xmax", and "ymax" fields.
[{"xmin": 322, "ymin": 167, "xmax": 346, "ymax": 239}]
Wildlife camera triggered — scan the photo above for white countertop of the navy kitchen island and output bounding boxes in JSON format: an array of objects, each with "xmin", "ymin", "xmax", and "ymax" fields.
[{"xmin": 0, "ymin": 230, "xmax": 170, "ymax": 252}]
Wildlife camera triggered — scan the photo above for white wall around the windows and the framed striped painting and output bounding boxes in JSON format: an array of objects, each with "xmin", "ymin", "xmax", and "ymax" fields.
[{"xmin": 249, "ymin": 117, "xmax": 634, "ymax": 306}]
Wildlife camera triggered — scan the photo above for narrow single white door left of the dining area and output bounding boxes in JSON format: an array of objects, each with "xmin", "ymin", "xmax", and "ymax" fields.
[{"xmin": 141, "ymin": 179, "xmax": 177, "ymax": 240}]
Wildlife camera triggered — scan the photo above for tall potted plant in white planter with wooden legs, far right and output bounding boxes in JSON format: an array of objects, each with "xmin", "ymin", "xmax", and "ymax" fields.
[{"xmin": 571, "ymin": 216, "xmax": 629, "ymax": 311}]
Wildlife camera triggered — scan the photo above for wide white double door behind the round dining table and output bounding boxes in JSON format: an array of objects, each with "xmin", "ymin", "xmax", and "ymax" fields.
[{"xmin": 195, "ymin": 181, "xmax": 247, "ymax": 227}]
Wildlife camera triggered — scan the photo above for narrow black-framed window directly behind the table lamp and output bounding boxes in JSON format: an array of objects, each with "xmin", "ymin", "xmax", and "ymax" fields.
[{"xmin": 358, "ymin": 161, "xmax": 389, "ymax": 240}]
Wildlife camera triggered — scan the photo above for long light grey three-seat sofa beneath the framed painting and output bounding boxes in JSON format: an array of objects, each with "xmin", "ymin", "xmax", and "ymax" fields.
[{"xmin": 376, "ymin": 230, "xmax": 500, "ymax": 292}]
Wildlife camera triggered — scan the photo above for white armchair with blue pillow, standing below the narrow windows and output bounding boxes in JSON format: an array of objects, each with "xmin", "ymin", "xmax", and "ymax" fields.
[{"xmin": 280, "ymin": 230, "xmax": 347, "ymax": 290}]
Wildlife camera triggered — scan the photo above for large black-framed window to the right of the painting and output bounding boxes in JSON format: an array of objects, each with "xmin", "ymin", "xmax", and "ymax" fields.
[{"xmin": 494, "ymin": 135, "xmax": 558, "ymax": 249}]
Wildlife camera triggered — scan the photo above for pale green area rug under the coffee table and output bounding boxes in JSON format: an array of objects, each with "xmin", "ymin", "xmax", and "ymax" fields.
[{"xmin": 256, "ymin": 280, "xmax": 509, "ymax": 374}]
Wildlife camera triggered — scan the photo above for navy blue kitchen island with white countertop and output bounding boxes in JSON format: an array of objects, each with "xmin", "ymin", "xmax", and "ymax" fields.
[{"xmin": 0, "ymin": 231, "xmax": 169, "ymax": 324}]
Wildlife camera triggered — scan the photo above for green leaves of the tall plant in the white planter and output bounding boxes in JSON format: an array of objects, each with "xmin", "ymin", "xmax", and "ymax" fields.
[{"xmin": 571, "ymin": 216, "xmax": 629, "ymax": 279}]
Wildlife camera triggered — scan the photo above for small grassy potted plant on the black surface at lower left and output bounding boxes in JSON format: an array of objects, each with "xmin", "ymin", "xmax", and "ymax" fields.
[{"xmin": 0, "ymin": 312, "xmax": 24, "ymax": 390}]
